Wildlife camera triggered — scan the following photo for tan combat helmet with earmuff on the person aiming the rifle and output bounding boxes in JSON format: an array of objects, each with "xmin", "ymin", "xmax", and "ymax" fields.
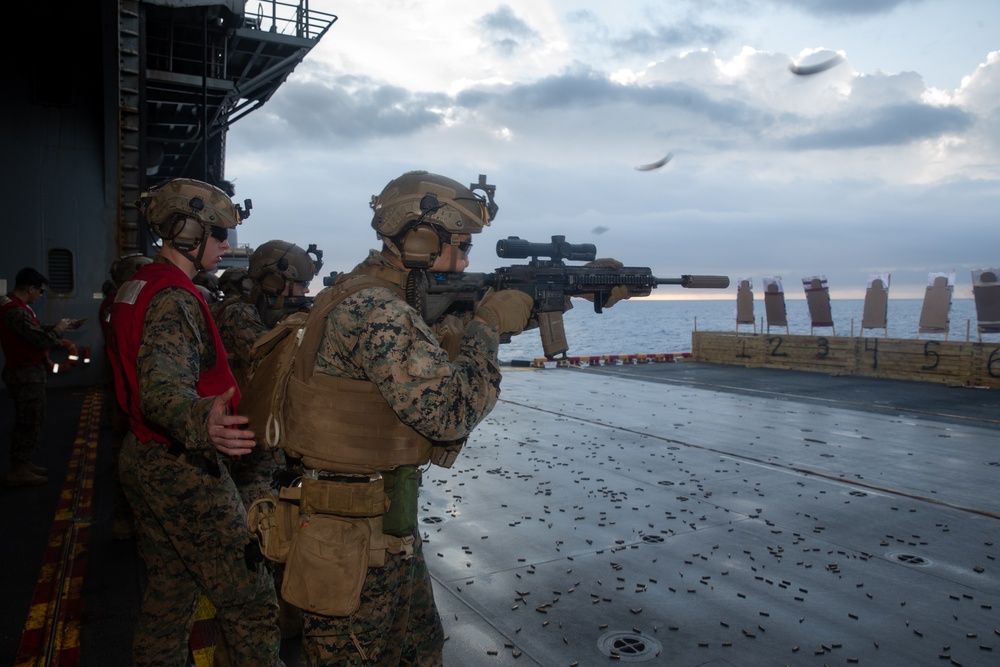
[{"xmin": 371, "ymin": 171, "xmax": 499, "ymax": 269}]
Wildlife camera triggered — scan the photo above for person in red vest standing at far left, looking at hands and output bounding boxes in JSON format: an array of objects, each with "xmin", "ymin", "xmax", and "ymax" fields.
[{"xmin": 0, "ymin": 267, "xmax": 73, "ymax": 486}]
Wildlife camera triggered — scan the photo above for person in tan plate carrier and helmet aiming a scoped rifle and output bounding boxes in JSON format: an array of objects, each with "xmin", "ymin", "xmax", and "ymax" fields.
[{"xmin": 245, "ymin": 171, "xmax": 728, "ymax": 665}]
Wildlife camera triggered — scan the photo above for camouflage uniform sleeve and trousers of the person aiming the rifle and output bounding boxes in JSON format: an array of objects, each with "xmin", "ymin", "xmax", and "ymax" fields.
[{"xmin": 303, "ymin": 250, "xmax": 500, "ymax": 666}]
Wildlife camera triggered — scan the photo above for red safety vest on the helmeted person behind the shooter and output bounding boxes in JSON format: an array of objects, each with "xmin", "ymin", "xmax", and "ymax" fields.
[{"xmin": 107, "ymin": 262, "xmax": 240, "ymax": 443}]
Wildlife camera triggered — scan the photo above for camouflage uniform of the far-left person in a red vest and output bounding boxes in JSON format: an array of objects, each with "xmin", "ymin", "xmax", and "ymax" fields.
[{"xmin": 0, "ymin": 294, "xmax": 62, "ymax": 463}]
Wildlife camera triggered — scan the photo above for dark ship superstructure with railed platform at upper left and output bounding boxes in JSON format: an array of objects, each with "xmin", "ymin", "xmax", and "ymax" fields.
[{"xmin": 0, "ymin": 0, "xmax": 337, "ymax": 386}]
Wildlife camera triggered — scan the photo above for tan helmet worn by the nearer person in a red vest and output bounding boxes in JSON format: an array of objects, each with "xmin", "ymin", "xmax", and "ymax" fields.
[{"xmin": 135, "ymin": 178, "xmax": 253, "ymax": 270}]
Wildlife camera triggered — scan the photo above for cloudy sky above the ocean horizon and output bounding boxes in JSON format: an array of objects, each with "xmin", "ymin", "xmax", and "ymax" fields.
[{"xmin": 227, "ymin": 0, "xmax": 1000, "ymax": 298}]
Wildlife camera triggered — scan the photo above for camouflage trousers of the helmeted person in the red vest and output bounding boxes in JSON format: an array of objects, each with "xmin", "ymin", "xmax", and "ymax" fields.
[{"xmin": 120, "ymin": 433, "xmax": 281, "ymax": 667}]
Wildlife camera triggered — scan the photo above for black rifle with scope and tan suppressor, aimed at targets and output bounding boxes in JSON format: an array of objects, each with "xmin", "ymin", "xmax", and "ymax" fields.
[{"xmin": 407, "ymin": 236, "xmax": 729, "ymax": 359}]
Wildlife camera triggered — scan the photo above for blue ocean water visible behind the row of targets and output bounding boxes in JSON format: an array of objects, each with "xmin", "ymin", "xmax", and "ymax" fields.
[{"xmin": 500, "ymin": 297, "xmax": 980, "ymax": 361}]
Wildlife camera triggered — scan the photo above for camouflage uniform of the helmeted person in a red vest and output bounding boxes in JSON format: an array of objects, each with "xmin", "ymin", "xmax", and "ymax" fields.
[{"xmin": 112, "ymin": 258, "xmax": 282, "ymax": 667}]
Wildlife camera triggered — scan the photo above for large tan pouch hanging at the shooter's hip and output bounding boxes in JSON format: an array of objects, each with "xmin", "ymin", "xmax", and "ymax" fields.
[{"xmin": 281, "ymin": 514, "xmax": 371, "ymax": 616}]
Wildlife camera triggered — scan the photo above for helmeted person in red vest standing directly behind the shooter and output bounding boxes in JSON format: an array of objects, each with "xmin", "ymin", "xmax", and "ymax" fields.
[{"xmin": 108, "ymin": 179, "xmax": 283, "ymax": 667}]
